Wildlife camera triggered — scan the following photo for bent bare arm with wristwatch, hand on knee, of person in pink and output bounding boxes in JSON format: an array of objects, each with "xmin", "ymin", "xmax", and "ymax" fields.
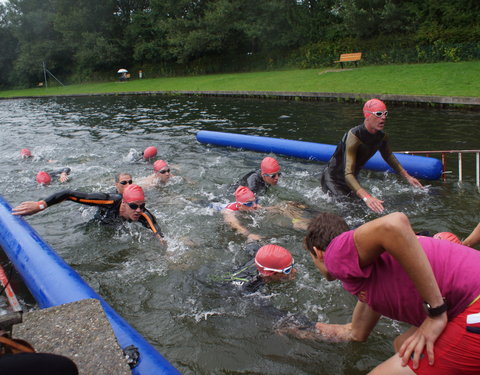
[{"xmin": 354, "ymin": 212, "xmax": 447, "ymax": 368}]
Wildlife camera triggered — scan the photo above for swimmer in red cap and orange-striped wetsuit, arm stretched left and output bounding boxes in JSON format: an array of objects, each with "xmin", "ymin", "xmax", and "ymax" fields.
[{"xmin": 12, "ymin": 184, "xmax": 164, "ymax": 242}]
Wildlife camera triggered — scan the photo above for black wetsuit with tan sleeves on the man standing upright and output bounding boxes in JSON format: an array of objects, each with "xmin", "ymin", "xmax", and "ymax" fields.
[{"xmin": 320, "ymin": 124, "xmax": 403, "ymax": 196}]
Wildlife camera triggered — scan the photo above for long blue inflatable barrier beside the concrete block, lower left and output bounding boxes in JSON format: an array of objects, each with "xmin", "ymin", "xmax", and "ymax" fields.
[{"xmin": 0, "ymin": 196, "xmax": 180, "ymax": 375}]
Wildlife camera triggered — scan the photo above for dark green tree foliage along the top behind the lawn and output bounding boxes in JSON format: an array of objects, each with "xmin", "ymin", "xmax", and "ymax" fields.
[{"xmin": 0, "ymin": 0, "xmax": 480, "ymax": 87}]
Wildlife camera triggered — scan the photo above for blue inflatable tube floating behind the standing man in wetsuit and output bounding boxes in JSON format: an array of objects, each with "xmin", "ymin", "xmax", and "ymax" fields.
[{"xmin": 197, "ymin": 130, "xmax": 442, "ymax": 180}]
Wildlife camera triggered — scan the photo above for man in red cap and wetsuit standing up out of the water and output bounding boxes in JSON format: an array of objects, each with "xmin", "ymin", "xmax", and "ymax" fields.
[{"xmin": 320, "ymin": 99, "xmax": 422, "ymax": 213}]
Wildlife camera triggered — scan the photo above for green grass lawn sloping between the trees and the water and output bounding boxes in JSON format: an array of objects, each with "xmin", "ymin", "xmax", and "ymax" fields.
[{"xmin": 0, "ymin": 61, "xmax": 480, "ymax": 97}]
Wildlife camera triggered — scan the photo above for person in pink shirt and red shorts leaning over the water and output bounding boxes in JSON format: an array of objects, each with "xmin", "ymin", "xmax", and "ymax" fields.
[{"xmin": 304, "ymin": 212, "xmax": 480, "ymax": 375}]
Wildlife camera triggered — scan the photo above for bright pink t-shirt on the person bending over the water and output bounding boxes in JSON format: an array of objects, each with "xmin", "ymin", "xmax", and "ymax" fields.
[{"xmin": 324, "ymin": 230, "xmax": 480, "ymax": 326}]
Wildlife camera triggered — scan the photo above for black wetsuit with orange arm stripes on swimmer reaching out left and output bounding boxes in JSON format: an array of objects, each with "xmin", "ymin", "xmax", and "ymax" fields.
[{"xmin": 45, "ymin": 190, "xmax": 163, "ymax": 237}]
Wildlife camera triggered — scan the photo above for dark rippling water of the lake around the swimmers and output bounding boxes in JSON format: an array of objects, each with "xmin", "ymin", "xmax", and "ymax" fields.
[{"xmin": 0, "ymin": 96, "xmax": 480, "ymax": 375}]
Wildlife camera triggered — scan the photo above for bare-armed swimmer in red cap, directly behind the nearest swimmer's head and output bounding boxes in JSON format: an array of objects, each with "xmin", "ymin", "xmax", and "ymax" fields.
[{"xmin": 222, "ymin": 186, "xmax": 262, "ymax": 241}]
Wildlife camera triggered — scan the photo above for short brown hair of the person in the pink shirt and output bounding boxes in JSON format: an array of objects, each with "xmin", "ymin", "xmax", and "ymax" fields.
[{"xmin": 303, "ymin": 212, "xmax": 350, "ymax": 256}]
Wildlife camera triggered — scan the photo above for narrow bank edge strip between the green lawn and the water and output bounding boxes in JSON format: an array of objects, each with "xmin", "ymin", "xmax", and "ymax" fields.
[{"xmin": 0, "ymin": 90, "xmax": 480, "ymax": 109}]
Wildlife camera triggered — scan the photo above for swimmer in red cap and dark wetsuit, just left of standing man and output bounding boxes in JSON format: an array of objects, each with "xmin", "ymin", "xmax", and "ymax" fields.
[{"xmin": 234, "ymin": 156, "xmax": 281, "ymax": 196}]
